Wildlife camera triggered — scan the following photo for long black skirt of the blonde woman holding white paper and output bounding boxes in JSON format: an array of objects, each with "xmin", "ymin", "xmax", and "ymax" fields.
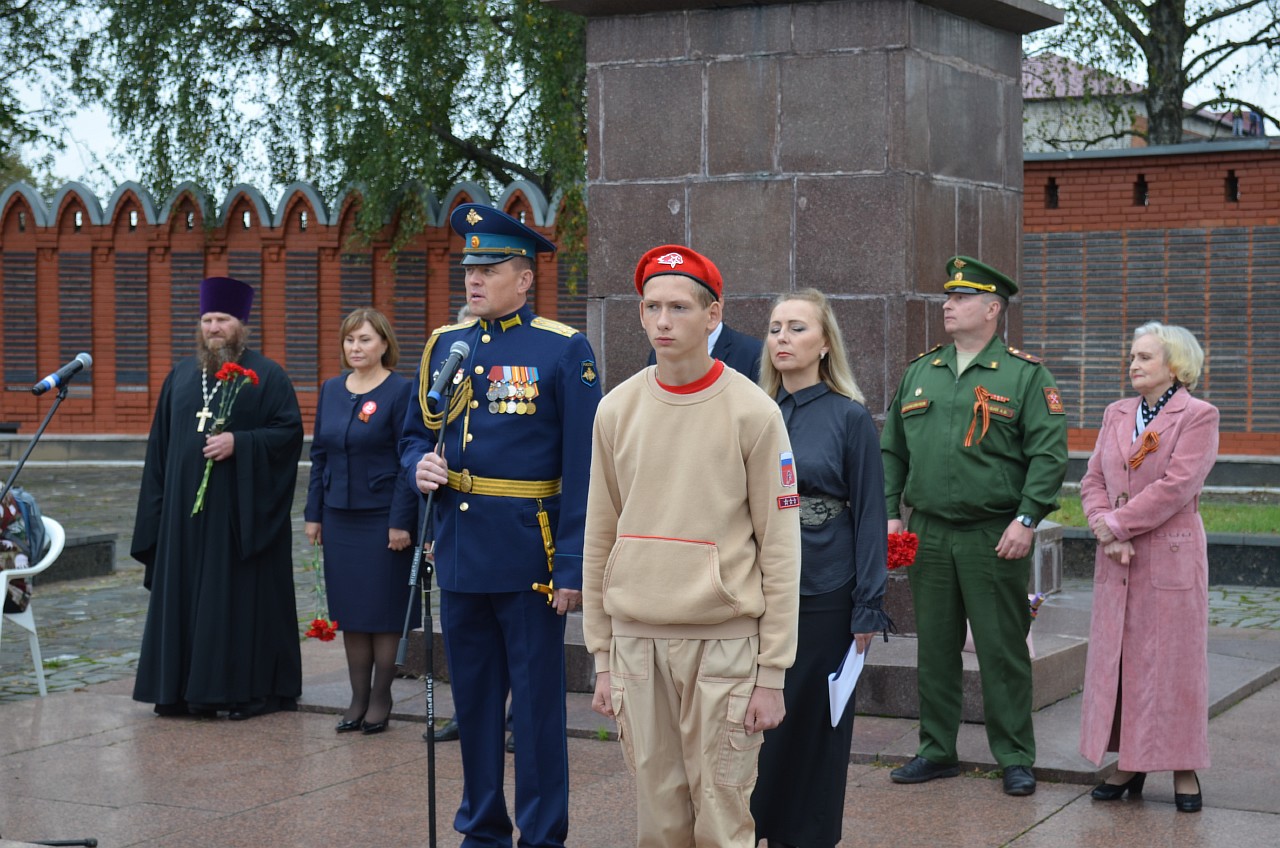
[{"xmin": 751, "ymin": 580, "xmax": 854, "ymax": 848}]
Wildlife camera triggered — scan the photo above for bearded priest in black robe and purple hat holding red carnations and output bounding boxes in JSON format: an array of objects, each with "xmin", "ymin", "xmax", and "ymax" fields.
[{"xmin": 131, "ymin": 277, "xmax": 302, "ymax": 720}]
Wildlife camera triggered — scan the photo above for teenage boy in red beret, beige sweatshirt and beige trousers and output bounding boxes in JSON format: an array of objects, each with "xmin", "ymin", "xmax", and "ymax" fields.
[{"xmin": 582, "ymin": 245, "xmax": 800, "ymax": 848}]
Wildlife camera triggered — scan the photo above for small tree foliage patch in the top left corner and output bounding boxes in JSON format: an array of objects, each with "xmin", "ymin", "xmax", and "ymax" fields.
[{"xmin": 0, "ymin": 0, "xmax": 82, "ymax": 175}]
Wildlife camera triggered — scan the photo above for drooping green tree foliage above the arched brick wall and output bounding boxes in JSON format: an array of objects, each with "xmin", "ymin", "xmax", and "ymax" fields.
[{"xmin": 79, "ymin": 0, "xmax": 586, "ymax": 242}]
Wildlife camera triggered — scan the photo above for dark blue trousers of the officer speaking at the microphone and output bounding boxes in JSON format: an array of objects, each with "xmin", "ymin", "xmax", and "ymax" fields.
[{"xmin": 440, "ymin": 591, "xmax": 568, "ymax": 848}]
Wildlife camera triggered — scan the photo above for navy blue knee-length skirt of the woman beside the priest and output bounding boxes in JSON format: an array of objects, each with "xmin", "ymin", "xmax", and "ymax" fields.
[{"xmin": 321, "ymin": 506, "xmax": 422, "ymax": 633}]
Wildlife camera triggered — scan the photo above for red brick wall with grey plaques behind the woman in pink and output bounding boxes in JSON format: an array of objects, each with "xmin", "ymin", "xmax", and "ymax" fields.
[{"xmin": 1023, "ymin": 141, "xmax": 1280, "ymax": 456}]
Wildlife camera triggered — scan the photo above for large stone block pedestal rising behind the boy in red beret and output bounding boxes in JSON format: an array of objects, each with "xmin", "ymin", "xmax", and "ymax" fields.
[{"xmin": 570, "ymin": 0, "xmax": 1051, "ymax": 412}]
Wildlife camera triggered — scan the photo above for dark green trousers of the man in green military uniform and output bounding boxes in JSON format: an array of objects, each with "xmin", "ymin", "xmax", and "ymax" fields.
[{"xmin": 908, "ymin": 512, "xmax": 1036, "ymax": 767}]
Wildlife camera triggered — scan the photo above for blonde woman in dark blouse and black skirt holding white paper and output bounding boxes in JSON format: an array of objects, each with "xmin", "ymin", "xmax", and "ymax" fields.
[{"xmin": 751, "ymin": 288, "xmax": 891, "ymax": 848}]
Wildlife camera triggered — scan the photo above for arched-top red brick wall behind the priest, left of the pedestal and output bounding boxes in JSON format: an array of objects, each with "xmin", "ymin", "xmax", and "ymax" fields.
[{"xmin": 0, "ymin": 183, "xmax": 586, "ymax": 434}]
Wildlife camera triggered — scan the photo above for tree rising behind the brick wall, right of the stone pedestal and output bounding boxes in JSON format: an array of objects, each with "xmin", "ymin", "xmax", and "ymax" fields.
[{"xmin": 1028, "ymin": 0, "xmax": 1280, "ymax": 145}]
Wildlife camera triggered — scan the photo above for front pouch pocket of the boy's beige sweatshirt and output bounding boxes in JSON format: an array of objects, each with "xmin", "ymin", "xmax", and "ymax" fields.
[{"xmin": 604, "ymin": 535, "xmax": 741, "ymax": 625}]
